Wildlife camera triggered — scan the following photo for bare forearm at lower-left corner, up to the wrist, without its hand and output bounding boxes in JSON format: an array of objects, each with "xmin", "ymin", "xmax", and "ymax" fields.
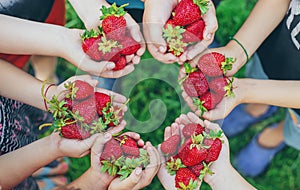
[{"xmin": 0, "ymin": 136, "xmax": 59, "ymax": 189}]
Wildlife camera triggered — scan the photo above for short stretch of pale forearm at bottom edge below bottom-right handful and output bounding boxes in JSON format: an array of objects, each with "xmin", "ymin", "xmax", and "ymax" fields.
[{"xmin": 208, "ymin": 165, "xmax": 255, "ymax": 190}]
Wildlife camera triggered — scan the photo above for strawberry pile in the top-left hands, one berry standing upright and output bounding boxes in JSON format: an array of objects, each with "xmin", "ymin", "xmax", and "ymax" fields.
[{"xmin": 81, "ymin": 3, "xmax": 141, "ymax": 70}]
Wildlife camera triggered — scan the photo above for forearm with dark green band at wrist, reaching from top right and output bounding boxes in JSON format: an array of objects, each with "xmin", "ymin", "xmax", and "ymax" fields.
[{"xmin": 228, "ymin": 0, "xmax": 290, "ymax": 62}]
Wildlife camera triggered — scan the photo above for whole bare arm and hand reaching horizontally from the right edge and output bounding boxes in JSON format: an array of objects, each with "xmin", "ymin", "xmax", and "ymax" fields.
[{"xmin": 203, "ymin": 78, "xmax": 300, "ymax": 120}]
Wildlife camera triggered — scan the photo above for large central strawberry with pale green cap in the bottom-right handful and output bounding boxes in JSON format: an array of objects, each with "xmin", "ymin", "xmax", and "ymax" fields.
[{"xmin": 179, "ymin": 135, "xmax": 208, "ymax": 166}]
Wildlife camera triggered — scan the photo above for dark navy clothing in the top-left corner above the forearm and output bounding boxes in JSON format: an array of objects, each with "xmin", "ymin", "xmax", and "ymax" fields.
[{"xmin": 0, "ymin": 0, "xmax": 54, "ymax": 22}]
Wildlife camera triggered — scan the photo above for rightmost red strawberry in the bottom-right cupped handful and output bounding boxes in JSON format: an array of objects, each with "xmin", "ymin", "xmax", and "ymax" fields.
[{"xmin": 204, "ymin": 138, "xmax": 222, "ymax": 163}]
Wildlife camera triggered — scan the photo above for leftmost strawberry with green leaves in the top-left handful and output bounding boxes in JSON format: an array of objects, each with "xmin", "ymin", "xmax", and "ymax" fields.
[{"xmin": 81, "ymin": 29, "xmax": 101, "ymax": 61}]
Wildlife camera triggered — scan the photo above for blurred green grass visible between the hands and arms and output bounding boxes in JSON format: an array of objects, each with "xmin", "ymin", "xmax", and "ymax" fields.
[{"xmin": 57, "ymin": 0, "xmax": 300, "ymax": 190}]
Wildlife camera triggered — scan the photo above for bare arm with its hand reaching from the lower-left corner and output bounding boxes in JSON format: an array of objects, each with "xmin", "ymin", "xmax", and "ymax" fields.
[{"xmin": 0, "ymin": 133, "xmax": 99, "ymax": 189}]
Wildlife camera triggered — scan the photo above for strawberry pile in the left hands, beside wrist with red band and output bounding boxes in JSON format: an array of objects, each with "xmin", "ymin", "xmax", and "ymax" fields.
[{"xmin": 41, "ymin": 80, "xmax": 122, "ymax": 140}]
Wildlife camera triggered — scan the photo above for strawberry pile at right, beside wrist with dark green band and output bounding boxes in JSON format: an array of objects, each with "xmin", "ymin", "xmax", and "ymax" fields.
[{"xmin": 180, "ymin": 52, "xmax": 235, "ymax": 114}]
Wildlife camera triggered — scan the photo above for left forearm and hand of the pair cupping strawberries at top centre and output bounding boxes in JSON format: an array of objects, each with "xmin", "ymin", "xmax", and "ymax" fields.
[{"xmin": 143, "ymin": 0, "xmax": 179, "ymax": 63}]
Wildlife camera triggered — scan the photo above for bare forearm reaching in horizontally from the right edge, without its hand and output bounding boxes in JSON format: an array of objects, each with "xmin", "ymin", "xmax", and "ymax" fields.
[{"xmin": 237, "ymin": 79, "xmax": 300, "ymax": 108}]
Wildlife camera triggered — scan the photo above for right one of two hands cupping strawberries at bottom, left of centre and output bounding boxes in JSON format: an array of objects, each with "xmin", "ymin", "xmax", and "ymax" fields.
[{"xmin": 108, "ymin": 142, "xmax": 160, "ymax": 190}]
